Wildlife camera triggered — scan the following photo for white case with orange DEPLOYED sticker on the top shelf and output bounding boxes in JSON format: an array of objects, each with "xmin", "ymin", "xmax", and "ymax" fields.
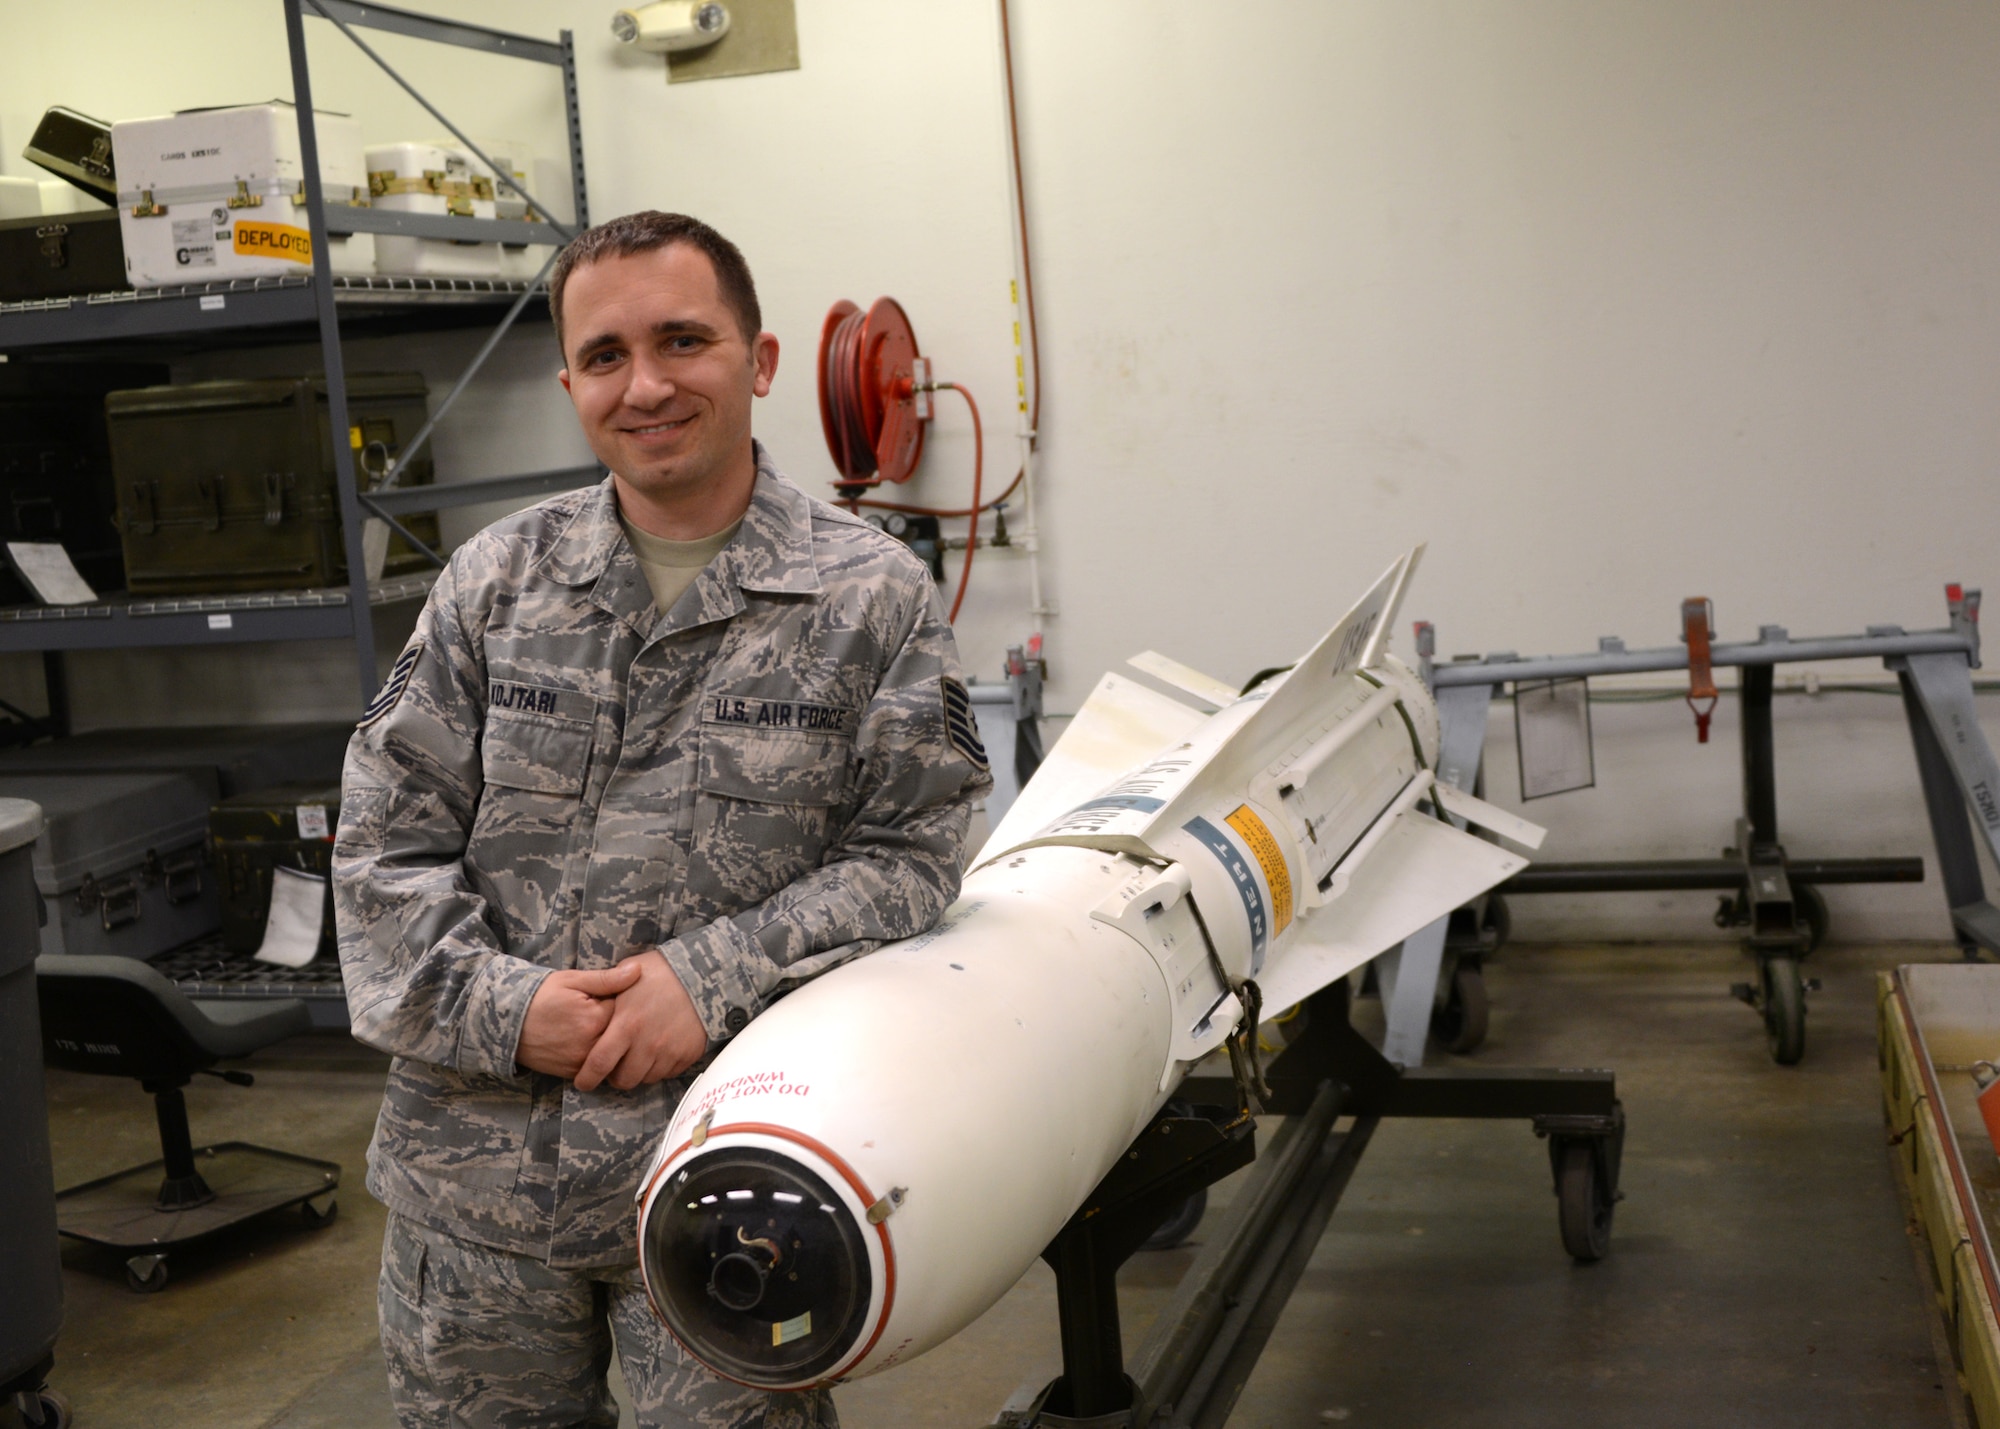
[{"xmin": 112, "ymin": 100, "xmax": 374, "ymax": 288}]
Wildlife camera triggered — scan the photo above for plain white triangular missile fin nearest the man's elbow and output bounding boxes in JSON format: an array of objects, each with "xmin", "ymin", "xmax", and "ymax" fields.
[{"xmin": 972, "ymin": 674, "xmax": 1208, "ymax": 869}]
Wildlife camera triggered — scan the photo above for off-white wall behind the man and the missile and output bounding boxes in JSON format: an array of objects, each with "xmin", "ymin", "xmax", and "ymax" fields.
[{"xmin": 0, "ymin": 0, "xmax": 2000, "ymax": 937}]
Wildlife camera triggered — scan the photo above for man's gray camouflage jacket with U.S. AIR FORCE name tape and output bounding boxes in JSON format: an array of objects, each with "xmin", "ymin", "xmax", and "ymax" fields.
[{"xmin": 334, "ymin": 448, "xmax": 990, "ymax": 1267}]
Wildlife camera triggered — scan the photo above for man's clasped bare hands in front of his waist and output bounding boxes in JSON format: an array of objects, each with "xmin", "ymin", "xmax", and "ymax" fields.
[{"xmin": 514, "ymin": 949, "xmax": 708, "ymax": 1091}]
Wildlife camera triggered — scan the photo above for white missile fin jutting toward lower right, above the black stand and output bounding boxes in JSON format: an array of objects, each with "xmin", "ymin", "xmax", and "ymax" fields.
[{"xmin": 1258, "ymin": 811, "xmax": 1528, "ymax": 1011}]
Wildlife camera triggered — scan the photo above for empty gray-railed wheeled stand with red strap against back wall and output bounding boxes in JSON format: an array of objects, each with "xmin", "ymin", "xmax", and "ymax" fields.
[{"xmin": 1380, "ymin": 584, "xmax": 2000, "ymax": 1065}]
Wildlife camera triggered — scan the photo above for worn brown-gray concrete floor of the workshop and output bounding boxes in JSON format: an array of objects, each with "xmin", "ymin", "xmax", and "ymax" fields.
[{"xmin": 23, "ymin": 945, "xmax": 1956, "ymax": 1429}]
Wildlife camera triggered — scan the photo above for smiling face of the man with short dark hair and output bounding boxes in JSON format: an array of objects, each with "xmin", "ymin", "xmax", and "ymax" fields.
[{"xmin": 560, "ymin": 242, "xmax": 778, "ymax": 540}]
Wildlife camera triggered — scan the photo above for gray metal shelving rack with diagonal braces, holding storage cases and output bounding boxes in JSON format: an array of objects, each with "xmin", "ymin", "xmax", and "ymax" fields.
[{"xmin": 0, "ymin": 0, "xmax": 600, "ymax": 708}]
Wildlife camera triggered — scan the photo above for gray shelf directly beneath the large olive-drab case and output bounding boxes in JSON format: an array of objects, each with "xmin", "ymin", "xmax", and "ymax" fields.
[{"xmin": 0, "ymin": 572, "xmax": 436, "ymax": 652}]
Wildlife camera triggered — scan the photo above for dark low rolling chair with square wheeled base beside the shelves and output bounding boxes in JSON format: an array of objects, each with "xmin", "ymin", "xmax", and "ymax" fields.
[{"xmin": 34, "ymin": 953, "xmax": 340, "ymax": 1291}]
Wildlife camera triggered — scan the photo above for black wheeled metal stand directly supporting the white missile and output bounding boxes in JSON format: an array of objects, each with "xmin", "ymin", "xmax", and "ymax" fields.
[{"xmin": 994, "ymin": 979, "xmax": 1624, "ymax": 1429}]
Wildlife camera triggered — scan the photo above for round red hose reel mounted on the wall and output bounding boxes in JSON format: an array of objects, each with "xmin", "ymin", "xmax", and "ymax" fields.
[{"xmin": 820, "ymin": 298, "xmax": 930, "ymax": 496}]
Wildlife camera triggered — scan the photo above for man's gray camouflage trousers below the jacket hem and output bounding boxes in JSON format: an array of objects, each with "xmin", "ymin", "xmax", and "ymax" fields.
[{"xmin": 378, "ymin": 1211, "xmax": 840, "ymax": 1429}]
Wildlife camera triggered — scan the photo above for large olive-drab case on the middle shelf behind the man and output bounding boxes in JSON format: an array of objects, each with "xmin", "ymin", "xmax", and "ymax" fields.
[{"xmin": 104, "ymin": 372, "xmax": 438, "ymax": 594}]
